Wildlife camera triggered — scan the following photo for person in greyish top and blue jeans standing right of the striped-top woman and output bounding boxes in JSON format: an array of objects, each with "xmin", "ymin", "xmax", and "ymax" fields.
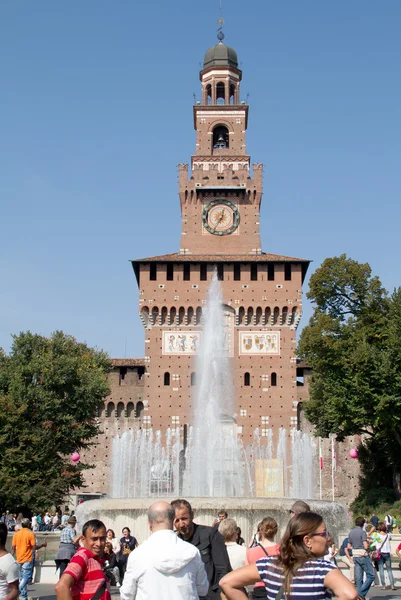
[{"xmin": 348, "ymin": 517, "xmax": 375, "ymax": 598}]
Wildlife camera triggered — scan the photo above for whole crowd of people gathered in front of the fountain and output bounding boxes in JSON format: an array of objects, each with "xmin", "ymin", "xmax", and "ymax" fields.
[{"xmin": 0, "ymin": 499, "xmax": 401, "ymax": 600}]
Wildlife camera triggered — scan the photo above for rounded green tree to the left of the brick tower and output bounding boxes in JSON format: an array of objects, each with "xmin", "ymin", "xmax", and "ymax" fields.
[{"xmin": 0, "ymin": 331, "xmax": 110, "ymax": 509}]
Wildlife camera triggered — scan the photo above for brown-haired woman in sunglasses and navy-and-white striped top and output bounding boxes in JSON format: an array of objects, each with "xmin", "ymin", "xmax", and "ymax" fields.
[{"xmin": 220, "ymin": 512, "xmax": 358, "ymax": 600}]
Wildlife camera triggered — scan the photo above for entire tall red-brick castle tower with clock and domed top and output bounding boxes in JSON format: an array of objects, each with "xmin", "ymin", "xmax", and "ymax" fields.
[{"xmin": 132, "ymin": 32, "xmax": 309, "ymax": 443}]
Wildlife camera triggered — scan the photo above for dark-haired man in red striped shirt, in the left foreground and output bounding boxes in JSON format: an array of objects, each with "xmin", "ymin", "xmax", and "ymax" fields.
[{"xmin": 55, "ymin": 519, "xmax": 111, "ymax": 600}]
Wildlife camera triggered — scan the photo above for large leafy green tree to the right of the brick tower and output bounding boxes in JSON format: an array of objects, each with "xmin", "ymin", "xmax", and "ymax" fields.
[{"xmin": 298, "ymin": 254, "xmax": 401, "ymax": 487}]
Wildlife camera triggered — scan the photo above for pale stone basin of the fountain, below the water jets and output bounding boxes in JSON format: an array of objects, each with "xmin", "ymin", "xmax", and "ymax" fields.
[{"xmin": 75, "ymin": 498, "xmax": 350, "ymax": 544}]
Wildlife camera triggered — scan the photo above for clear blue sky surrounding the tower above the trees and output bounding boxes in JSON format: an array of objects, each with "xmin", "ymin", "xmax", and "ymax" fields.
[{"xmin": 0, "ymin": 0, "xmax": 401, "ymax": 357}]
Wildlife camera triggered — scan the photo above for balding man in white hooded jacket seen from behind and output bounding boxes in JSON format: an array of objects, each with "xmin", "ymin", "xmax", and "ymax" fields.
[{"xmin": 120, "ymin": 502, "xmax": 209, "ymax": 600}]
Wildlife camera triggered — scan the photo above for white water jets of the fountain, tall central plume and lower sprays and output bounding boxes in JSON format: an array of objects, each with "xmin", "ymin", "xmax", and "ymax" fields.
[{"xmin": 111, "ymin": 275, "xmax": 315, "ymax": 498}]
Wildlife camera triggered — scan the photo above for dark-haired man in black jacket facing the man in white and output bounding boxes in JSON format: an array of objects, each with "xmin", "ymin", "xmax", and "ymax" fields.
[{"xmin": 171, "ymin": 499, "xmax": 231, "ymax": 600}]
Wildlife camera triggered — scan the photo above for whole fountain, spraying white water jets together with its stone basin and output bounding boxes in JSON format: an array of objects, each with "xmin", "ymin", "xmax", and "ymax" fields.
[{"xmin": 77, "ymin": 274, "xmax": 345, "ymax": 539}]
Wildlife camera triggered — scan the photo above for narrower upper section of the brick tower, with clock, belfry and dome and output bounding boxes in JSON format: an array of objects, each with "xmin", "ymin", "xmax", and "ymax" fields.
[{"xmin": 179, "ymin": 31, "xmax": 263, "ymax": 255}]
